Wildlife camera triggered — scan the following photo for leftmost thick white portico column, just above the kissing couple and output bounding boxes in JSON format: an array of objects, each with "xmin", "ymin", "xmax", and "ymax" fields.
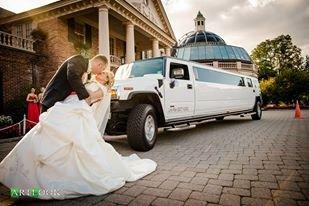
[{"xmin": 99, "ymin": 6, "xmax": 110, "ymax": 62}]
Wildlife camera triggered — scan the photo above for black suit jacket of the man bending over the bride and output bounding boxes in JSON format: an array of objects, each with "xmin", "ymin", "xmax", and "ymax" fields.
[{"xmin": 41, "ymin": 55, "xmax": 89, "ymax": 112}]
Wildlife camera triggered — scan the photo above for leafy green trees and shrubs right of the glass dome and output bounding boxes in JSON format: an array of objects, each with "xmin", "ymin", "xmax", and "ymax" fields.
[{"xmin": 251, "ymin": 35, "xmax": 309, "ymax": 103}]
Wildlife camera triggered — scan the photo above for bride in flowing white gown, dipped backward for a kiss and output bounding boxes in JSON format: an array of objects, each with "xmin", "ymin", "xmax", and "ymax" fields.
[{"xmin": 0, "ymin": 69, "xmax": 157, "ymax": 199}]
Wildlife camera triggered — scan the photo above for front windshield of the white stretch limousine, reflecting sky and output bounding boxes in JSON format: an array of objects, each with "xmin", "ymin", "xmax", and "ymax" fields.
[{"xmin": 115, "ymin": 58, "xmax": 164, "ymax": 80}]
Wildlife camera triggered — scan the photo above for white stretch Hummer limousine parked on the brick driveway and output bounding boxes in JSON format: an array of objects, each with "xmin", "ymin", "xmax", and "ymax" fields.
[{"xmin": 106, "ymin": 57, "xmax": 262, "ymax": 151}]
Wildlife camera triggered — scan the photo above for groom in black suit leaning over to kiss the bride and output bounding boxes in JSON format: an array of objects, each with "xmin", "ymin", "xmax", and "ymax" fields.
[{"xmin": 41, "ymin": 54, "xmax": 108, "ymax": 113}]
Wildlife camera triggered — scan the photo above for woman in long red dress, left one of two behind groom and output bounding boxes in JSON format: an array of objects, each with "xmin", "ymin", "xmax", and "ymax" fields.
[{"xmin": 27, "ymin": 88, "xmax": 40, "ymax": 122}]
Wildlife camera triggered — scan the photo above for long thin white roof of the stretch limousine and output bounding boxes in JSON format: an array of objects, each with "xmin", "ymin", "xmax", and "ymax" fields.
[{"xmin": 133, "ymin": 56, "xmax": 257, "ymax": 79}]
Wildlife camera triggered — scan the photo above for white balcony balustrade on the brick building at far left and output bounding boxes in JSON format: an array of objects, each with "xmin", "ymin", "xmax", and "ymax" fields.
[{"xmin": 0, "ymin": 31, "xmax": 34, "ymax": 52}]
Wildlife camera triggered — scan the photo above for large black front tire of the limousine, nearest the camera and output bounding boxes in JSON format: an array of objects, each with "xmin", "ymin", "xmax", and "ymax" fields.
[{"xmin": 127, "ymin": 104, "xmax": 158, "ymax": 151}]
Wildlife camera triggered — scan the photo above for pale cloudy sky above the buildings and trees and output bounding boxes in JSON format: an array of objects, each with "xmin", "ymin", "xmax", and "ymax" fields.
[{"xmin": 0, "ymin": 0, "xmax": 309, "ymax": 56}]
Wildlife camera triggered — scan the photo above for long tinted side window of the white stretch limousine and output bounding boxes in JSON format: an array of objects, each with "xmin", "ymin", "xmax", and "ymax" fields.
[{"xmin": 193, "ymin": 67, "xmax": 246, "ymax": 87}]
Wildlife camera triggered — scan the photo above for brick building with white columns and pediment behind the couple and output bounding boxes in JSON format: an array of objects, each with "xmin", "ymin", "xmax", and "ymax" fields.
[{"xmin": 0, "ymin": 0, "xmax": 176, "ymax": 112}]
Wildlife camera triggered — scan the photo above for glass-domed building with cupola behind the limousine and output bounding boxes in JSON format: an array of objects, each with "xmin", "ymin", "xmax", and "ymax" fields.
[{"xmin": 174, "ymin": 12, "xmax": 257, "ymax": 77}]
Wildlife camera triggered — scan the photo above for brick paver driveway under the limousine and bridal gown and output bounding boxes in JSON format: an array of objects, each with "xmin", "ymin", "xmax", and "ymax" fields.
[{"xmin": 0, "ymin": 110, "xmax": 309, "ymax": 206}]
